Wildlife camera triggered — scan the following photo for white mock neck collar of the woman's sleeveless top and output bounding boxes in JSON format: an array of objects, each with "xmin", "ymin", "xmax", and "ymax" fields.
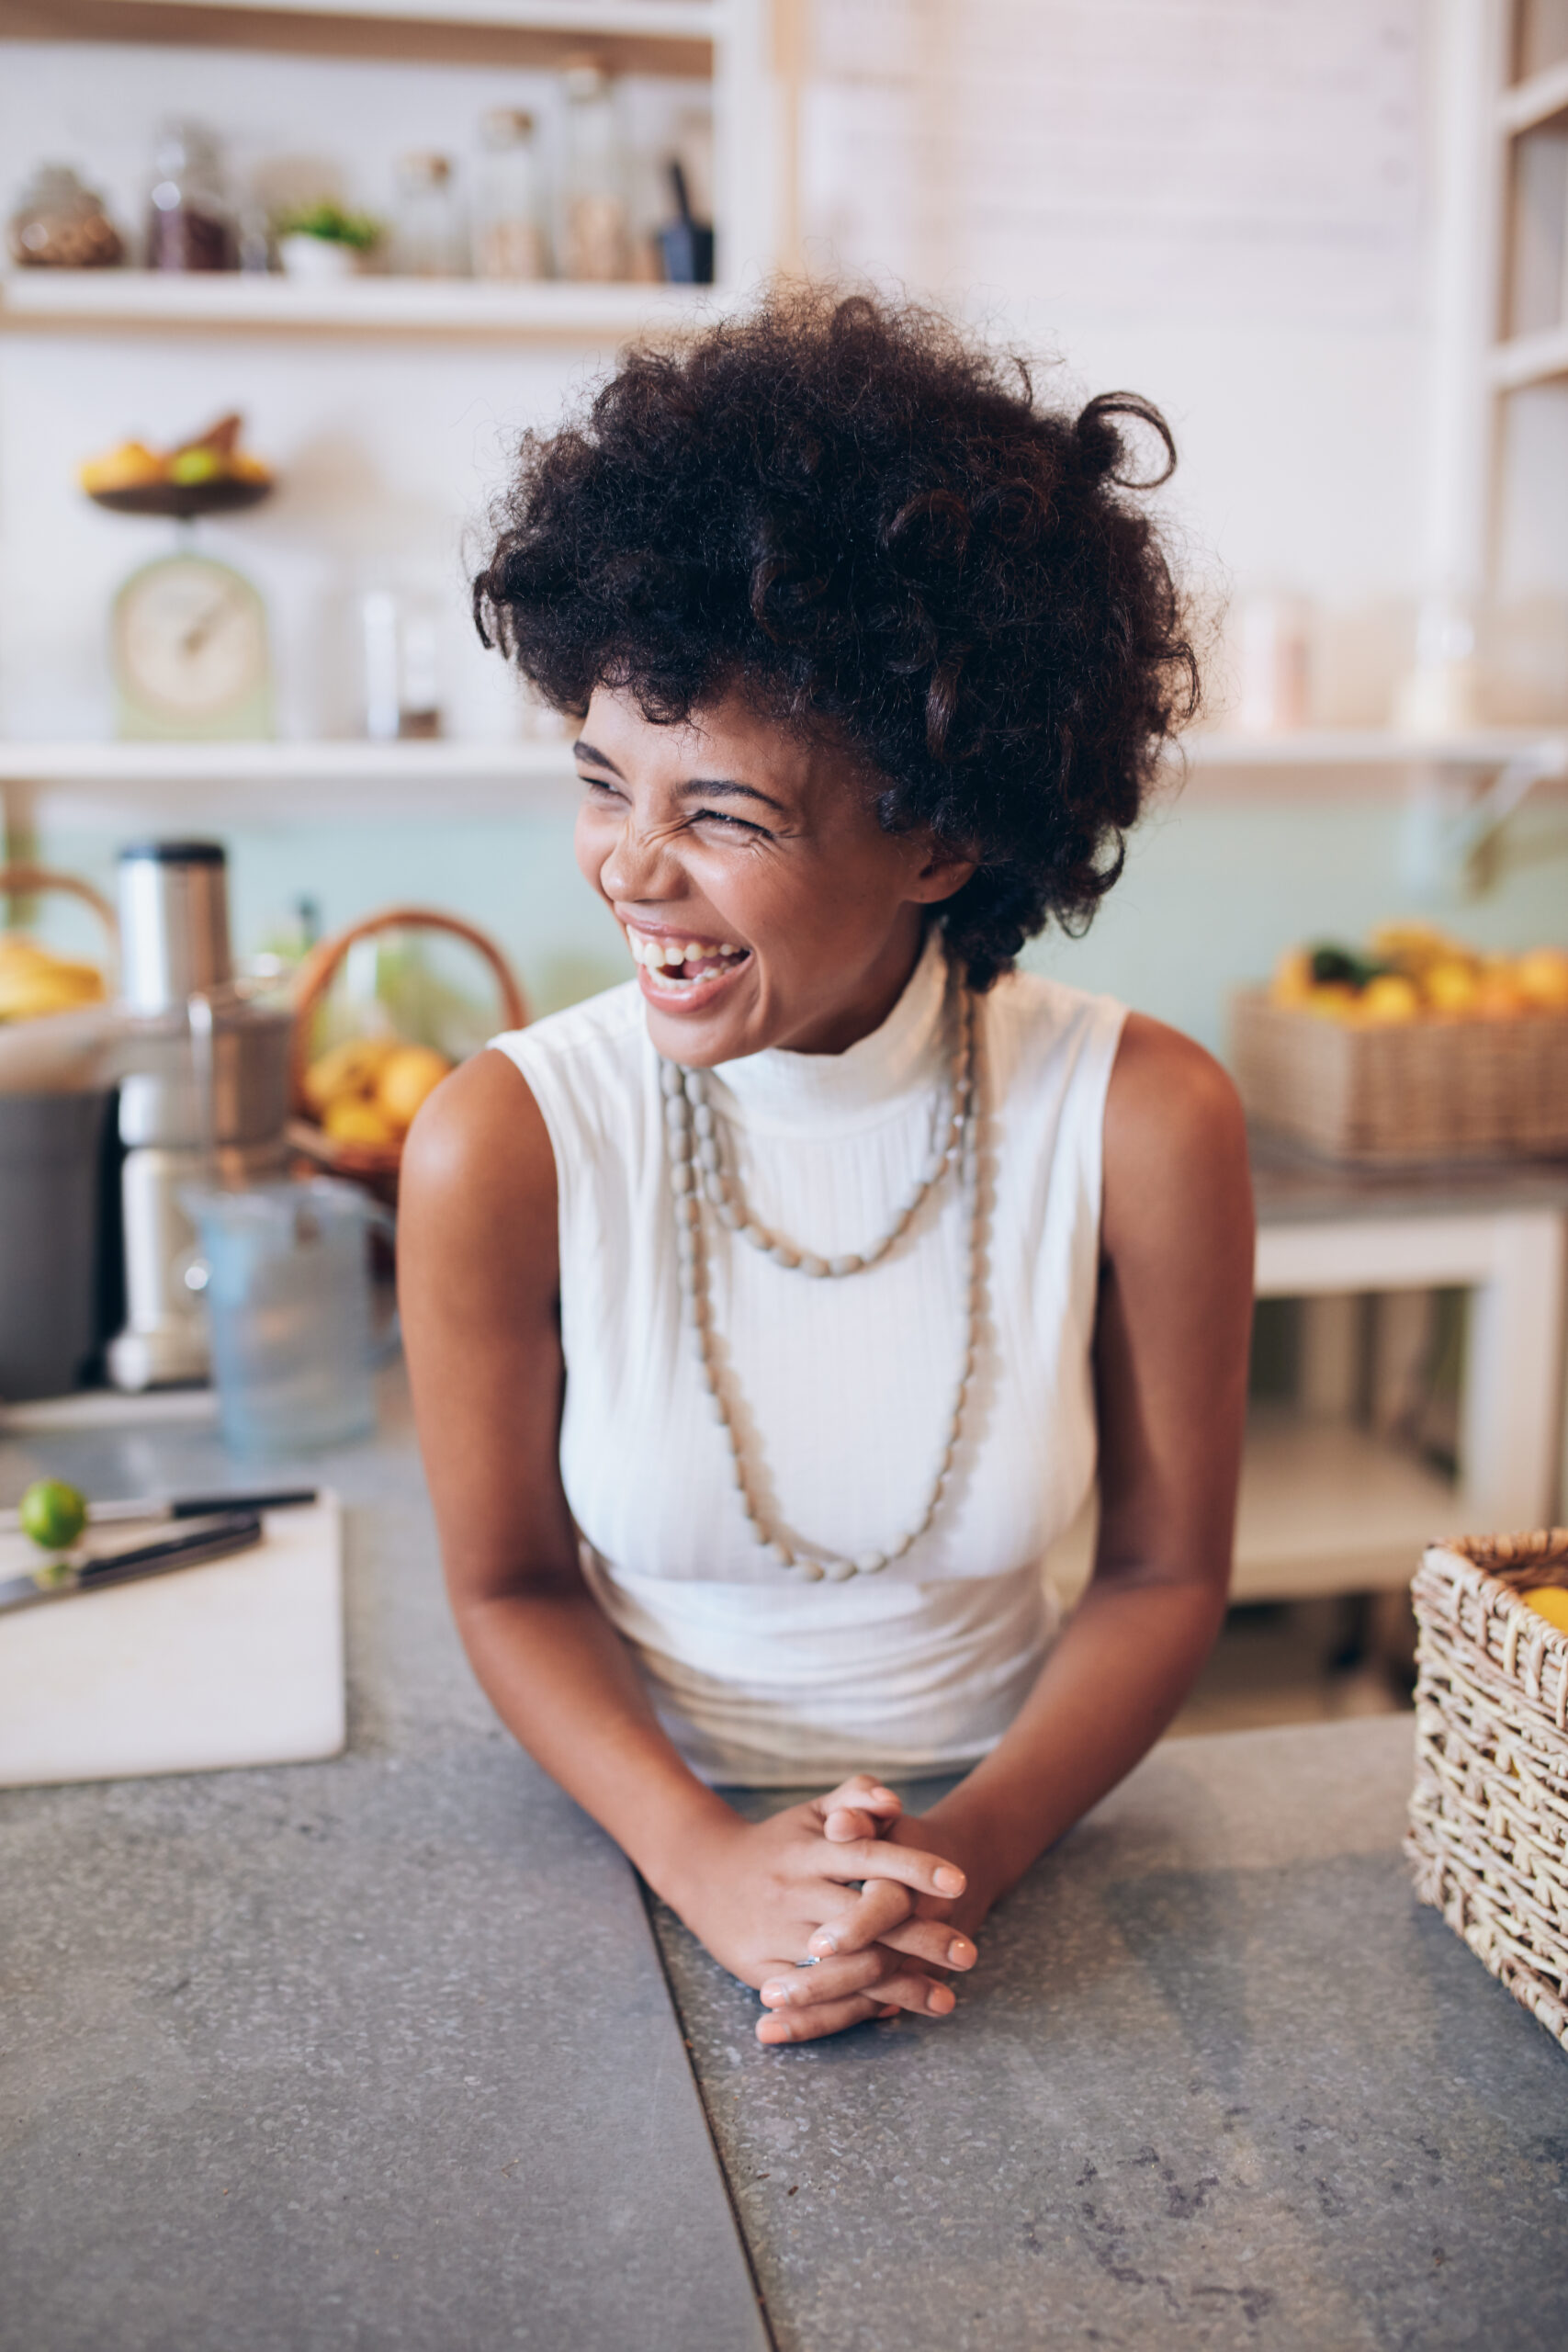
[{"xmin": 712, "ymin": 924, "xmax": 947, "ymax": 1131}]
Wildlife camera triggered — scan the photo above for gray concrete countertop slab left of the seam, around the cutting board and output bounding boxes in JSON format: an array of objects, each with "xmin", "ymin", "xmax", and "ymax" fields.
[{"xmin": 0, "ymin": 1383, "xmax": 766, "ymax": 2352}]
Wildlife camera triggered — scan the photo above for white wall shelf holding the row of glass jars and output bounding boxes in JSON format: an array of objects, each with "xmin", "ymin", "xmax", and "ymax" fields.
[{"xmin": 0, "ymin": 270, "xmax": 724, "ymax": 344}]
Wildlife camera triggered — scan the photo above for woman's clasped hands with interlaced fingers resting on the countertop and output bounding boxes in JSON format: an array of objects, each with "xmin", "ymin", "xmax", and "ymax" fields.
[{"xmin": 677, "ymin": 1773, "xmax": 985, "ymax": 2044}]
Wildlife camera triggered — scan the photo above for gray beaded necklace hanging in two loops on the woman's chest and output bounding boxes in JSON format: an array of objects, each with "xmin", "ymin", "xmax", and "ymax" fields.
[{"xmin": 659, "ymin": 964, "xmax": 983, "ymax": 1583}]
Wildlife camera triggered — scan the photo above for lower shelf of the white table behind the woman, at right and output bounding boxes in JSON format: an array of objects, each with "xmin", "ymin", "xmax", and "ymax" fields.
[{"xmin": 1232, "ymin": 1411, "xmax": 1464, "ymax": 1601}]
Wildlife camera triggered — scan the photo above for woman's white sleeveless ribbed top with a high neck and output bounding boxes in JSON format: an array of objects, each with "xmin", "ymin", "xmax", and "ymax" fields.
[{"xmin": 493, "ymin": 932, "xmax": 1123, "ymax": 1788}]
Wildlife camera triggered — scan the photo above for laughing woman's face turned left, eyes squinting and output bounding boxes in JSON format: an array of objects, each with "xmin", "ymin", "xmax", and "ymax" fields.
[{"xmin": 576, "ymin": 687, "xmax": 974, "ymax": 1068}]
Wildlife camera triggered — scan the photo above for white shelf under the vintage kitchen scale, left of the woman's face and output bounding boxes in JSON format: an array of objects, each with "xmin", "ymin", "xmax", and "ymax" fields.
[{"xmin": 0, "ymin": 739, "xmax": 576, "ymax": 828}]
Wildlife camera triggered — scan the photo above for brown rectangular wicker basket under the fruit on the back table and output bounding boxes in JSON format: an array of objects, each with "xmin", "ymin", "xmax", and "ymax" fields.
[{"xmin": 1232, "ymin": 990, "xmax": 1568, "ymax": 1167}]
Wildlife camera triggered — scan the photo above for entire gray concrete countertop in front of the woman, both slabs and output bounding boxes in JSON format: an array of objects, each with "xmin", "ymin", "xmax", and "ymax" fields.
[{"xmin": 0, "ymin": 1381, "xmax": 1568, "ymax": 2352}]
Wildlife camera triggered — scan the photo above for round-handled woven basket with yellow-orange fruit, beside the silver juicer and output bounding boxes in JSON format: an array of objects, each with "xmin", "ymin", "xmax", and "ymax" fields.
[{"xmin": 289, "ymin": 906, "xmax": 529, "ymax": 1200}]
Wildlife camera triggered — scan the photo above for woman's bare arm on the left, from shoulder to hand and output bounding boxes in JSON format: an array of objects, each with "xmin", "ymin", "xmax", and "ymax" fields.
[{"xmin": 398, "ymin": 1054, "xmax": 974, "ymax": 2008}]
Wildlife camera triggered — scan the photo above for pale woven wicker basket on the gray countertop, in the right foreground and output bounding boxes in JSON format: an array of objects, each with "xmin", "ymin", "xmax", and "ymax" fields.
[{"xmin": 1405, "ymin": 1526, "xmax": 1568, "ymax": 2049}]
